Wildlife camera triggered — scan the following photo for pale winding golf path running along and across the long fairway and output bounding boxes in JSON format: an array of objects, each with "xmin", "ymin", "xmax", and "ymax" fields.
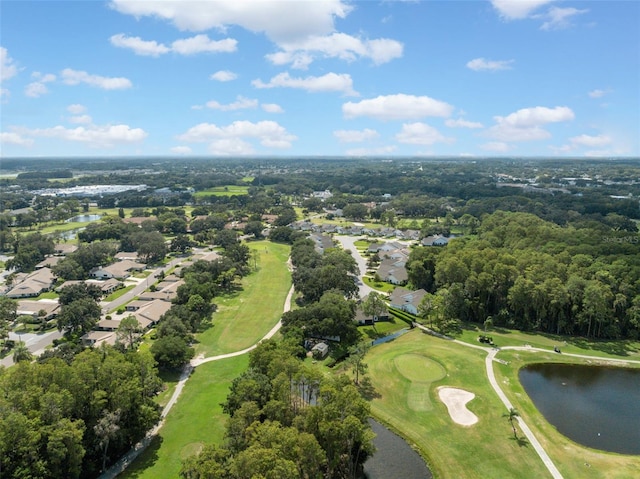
[{"xmin": 98, "ymin": 285, "xmax": 294, "ymax": 479}]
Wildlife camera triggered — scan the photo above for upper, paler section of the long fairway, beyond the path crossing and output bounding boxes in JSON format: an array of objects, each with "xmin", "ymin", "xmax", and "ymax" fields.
[{"xmin": 195, "ymin": 241, "xmax": 291, "ymax": 357}]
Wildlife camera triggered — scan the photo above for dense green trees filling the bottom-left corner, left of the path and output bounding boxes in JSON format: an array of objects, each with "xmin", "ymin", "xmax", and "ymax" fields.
[{"xmin": 0, "ymin": 346, "xmax": 161, "ymax": 479}]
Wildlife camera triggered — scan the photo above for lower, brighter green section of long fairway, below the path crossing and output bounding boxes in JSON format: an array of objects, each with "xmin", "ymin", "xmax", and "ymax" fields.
[{"xmin": 118, "ymin": 354, "xmax": 249, "ymax": 479}]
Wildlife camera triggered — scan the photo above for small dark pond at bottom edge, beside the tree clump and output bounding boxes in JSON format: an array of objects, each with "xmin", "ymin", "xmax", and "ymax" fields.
[{"xmin": 364, "ymin": 419, "xmax": 433, "ymax": 479}]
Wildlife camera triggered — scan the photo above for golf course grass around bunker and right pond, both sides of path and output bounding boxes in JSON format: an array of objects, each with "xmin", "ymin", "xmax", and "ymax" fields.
[{"xmin": 366, "ymin": 330, "xmax": 640, "ymax": 479}]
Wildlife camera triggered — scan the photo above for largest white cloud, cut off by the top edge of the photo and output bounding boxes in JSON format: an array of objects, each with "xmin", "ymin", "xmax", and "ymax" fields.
[{"xmin": 110, "ymin": 0, "xmax": 352, "ymax": 43}]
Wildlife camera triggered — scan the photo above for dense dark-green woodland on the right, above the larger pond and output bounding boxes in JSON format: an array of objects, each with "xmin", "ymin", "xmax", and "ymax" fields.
[{"xmin": 408, "ymin": 211, "xmax": 640, "ymax": 338}]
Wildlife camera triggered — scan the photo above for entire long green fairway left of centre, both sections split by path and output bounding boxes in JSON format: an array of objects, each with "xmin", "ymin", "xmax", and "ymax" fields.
[{"xmin": 121, "ymin": 241, "xmax": 291, "ymax": 479}]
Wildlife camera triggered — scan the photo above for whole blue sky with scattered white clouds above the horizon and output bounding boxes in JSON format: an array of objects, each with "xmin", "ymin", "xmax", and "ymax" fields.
[{"xmin": 0, "ymin": 0, "xmax": 640, "ymax": 157}]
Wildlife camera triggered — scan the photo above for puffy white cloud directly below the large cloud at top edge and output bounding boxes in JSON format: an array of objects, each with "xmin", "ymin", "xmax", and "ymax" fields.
[{"xmin": 266, "ymin": 33, "xmax": 404, "ymax": 69}]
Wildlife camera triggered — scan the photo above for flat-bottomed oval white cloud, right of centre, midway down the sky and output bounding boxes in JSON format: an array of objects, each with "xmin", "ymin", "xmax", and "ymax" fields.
[{"xmin": 342, "ymin": 93, "xmax": 453, "ymax": 120}]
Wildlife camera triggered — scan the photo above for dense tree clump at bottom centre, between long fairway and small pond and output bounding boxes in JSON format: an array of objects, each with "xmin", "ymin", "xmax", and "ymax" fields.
[{"xmin": 180, "ymin": 340, "xmax": 373, "ymax": 479}]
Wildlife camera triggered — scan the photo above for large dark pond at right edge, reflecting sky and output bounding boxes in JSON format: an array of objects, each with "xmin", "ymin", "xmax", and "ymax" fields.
[{"xmin": 519, "ymin": 364, "xmax": 640, "ymax": 454}]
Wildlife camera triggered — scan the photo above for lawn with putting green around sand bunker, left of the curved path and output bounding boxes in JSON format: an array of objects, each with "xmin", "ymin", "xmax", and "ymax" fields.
[{"xmin": 366, "ymin": 330, "xmax": 548, "ymax": 479}]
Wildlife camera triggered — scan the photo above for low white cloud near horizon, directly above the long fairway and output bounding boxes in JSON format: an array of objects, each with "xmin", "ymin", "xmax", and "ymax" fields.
[{"xmin": 178, "ymin": 121, "xmax": 297, "ymax": 148}]
